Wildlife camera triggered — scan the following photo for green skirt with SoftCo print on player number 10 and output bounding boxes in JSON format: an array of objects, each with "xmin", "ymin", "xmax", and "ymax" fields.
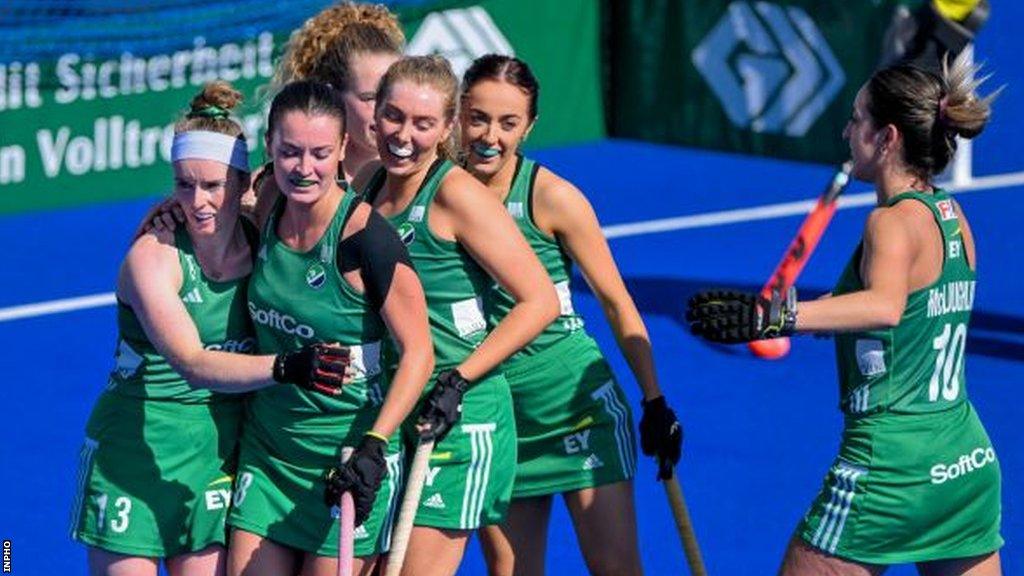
[{"xmin": 798, "ymin": 402, "xmax": 1002, "ymax": 565}]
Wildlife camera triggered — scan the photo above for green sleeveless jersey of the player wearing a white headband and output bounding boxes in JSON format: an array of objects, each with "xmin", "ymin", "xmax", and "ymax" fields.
[{"xmin": 108, "ymin": 222, "xmax": 255, "ymax": 404}]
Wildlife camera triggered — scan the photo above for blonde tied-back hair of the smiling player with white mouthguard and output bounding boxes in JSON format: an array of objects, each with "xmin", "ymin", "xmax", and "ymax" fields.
[{"xmin": 376, "ymin": 55, "xmax": 459, "ymax": 162}]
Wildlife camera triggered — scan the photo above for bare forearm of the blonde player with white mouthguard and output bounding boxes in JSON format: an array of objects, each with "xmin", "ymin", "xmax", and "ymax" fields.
[{"xmin": 459, "ymin": 295, "xmax": 558, "ymax": 382}]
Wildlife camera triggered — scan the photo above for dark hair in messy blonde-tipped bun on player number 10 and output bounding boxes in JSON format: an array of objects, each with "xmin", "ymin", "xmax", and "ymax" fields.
[{"xmin": 865, "ymin": 51, "xmax": 1001, "ymax": 181}]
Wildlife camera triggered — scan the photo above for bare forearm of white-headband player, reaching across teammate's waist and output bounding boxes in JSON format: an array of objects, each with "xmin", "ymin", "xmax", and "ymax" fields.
[{"xmin": 168, "ymin": 351, "xmax": 275, "ymax": 393}]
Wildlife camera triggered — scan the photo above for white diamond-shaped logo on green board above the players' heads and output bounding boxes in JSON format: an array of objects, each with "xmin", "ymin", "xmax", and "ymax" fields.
[{"xmin": 406, "ymin": 6, "xmax": 515, "ymax": 78}]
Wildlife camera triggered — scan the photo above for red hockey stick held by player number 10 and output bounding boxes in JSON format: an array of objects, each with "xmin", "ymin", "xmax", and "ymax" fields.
[{"xmin": 746, "ymin": 160, "xmax": 853, "ymax": 360}]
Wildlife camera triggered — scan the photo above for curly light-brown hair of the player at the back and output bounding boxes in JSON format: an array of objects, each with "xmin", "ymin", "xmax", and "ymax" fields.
[{"xmin": 273, "ymin": 2, "xmax": 406, "ymax": 90}]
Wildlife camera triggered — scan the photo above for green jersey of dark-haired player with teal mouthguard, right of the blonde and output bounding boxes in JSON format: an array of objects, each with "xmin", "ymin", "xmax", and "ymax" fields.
[{"xmin": 488, "ymin": 156, "xmax": 583, "ymax": 361}]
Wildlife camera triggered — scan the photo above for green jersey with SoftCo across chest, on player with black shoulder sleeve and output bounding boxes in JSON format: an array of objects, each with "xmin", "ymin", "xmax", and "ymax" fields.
[{"xmin": 249, "ymin": 191, "xmax": 387, "ymax": 414}]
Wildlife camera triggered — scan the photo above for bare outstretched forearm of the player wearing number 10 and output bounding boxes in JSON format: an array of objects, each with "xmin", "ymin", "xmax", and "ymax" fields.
[{"xmin": 797, "ymin": 290, "xmax": 906, "ymax": 332}]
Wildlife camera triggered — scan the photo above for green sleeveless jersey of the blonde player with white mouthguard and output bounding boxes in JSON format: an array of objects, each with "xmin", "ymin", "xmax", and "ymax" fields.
[{"xmin": 366, "ymin": 160, "xmax": 494, "ymax": 373}]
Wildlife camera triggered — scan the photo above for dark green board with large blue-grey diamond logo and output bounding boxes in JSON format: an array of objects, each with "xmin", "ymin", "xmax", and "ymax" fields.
[{"xmin": 609, "ymin": 0, "xmax": 898, "ymax": 163}]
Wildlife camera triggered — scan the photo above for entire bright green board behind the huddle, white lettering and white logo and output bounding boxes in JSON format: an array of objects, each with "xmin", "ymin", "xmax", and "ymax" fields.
[{"xmin": 0, "ymin": 0, "xmax": 604, "ymax": 213}]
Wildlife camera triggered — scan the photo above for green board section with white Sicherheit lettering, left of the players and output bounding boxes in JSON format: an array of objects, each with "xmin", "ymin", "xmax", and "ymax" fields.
[{"xmin": 0, "ymin": 32, "xmax": 283, "ymax": 212}]
